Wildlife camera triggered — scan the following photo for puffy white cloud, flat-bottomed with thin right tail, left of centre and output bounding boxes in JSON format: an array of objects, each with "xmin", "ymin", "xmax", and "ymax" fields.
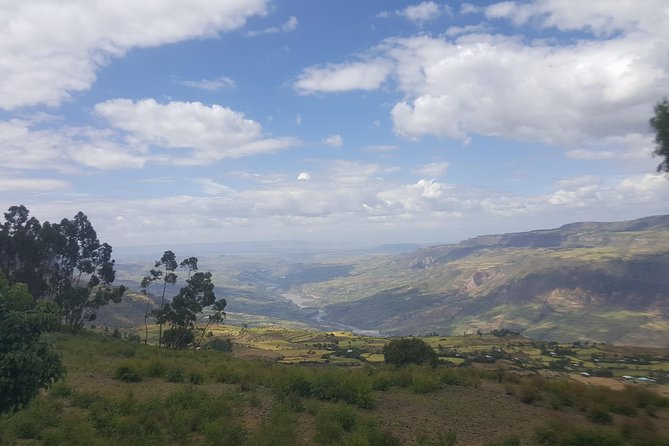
[{"xmin": 95, "ymin": 99, "xmax": 297, "ymax": 165}]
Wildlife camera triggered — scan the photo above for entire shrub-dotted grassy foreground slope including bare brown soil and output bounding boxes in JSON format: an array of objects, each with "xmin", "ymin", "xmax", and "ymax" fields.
[{"xmin": 0, "ymin": 334, "xmax": 669, "ymax": 446}]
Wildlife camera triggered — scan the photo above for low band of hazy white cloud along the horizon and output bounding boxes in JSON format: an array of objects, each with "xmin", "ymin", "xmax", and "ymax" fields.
[{"xmin": 6, "ymin": 166, "xmax": 669, "ymax": 244}]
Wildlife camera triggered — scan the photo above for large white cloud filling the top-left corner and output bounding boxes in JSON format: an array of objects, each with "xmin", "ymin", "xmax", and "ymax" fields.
[{"xmin": 0, "ymin": 0, "xmax": 268, "ymax": 110}]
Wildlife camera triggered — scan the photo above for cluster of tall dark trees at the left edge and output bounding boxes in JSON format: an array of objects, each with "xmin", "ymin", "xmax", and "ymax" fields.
[{"xmin": 0, "ymin": 205, "xmax": 125, "ymax": 332}]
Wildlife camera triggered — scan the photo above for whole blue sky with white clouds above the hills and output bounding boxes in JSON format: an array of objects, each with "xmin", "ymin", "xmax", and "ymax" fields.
[{"xmin": 0, "ymin": 0, "xmax": 669, "ymax": 249}]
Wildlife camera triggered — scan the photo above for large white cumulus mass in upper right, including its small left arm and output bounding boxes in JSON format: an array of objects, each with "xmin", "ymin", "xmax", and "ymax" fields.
[{"xmin": 298, "ymin": 0, "xmax": 669, "ymax": 159}]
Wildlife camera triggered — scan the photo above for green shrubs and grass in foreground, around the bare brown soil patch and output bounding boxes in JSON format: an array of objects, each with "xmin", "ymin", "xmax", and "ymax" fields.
[{"xmin": 0, "ymin": 334, "xmax": 669, "ymax": 446}]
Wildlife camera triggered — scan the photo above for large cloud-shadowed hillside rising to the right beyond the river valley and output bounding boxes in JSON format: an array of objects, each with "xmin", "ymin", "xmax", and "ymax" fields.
[{"xmin": 301, "ymin": 216, "xmax": 669, "ymax": 345}]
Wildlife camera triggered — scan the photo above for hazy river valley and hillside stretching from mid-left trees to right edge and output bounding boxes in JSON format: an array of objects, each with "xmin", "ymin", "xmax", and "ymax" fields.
[{"xmin": 105, "ymin": 216, "xmax": 669, "ymax": 346}]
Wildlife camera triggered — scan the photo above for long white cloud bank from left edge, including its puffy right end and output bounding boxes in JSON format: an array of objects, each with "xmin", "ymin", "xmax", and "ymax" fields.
[{"xmin": 0, "ymin": 99, "xmax": 299, "ymax": 173}]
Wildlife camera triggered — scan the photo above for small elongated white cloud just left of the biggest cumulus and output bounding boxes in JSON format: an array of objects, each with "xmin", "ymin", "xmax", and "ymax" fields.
[{"xmin": 295, "ymin": 60, "xmax": 391, "ymax": 94}]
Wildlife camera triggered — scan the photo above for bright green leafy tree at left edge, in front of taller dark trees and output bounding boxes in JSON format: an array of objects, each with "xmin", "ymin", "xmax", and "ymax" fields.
[{"xmin": 0, "ymin": 272, "xmax": 65, "ymax": 413}]
